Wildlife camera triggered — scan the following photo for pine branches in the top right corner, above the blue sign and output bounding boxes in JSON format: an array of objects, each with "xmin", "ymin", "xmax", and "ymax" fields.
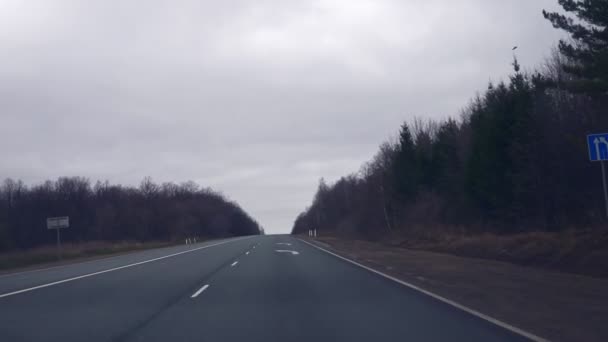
[{"xmin": 543, "ymin": 0, "xmax": 608, "ymax": 95}]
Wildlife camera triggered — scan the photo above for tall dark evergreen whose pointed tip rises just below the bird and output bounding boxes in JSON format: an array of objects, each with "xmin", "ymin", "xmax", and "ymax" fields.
[{"xmin": 466, "ymin": 59, "xmax": 532, "ymax": 221}]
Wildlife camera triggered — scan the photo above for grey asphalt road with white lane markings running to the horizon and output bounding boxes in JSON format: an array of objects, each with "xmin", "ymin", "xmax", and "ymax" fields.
[{"xmin": 0, "ymin": 236, "xmax": 527, "ymax": 342}]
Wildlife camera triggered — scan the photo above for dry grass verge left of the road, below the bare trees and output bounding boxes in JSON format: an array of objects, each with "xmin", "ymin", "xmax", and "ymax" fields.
[{"xmin": 0, "ymin": 241, "xmax": 177, "ymax": 274}]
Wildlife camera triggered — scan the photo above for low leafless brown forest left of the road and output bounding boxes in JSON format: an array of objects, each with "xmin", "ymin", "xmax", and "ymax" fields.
[{"xmin": 0, "ymin": 177, "xmax": 261, "ymax": 251}]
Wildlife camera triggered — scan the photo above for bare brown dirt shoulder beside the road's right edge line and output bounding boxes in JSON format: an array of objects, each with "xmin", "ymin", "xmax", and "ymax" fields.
[{"xmin": 301, "ymin": 237, "xmax": 608, "ymax": 341}]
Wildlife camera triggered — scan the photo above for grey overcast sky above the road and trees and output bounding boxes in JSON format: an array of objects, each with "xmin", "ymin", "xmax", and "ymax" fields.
[{"xmin": 0, "ymin": 0, "xmax": 559, "ymax": 233}]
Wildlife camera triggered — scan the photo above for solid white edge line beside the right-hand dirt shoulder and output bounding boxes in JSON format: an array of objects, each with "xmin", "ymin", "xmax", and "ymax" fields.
[{"xmin": 297, "ymin": 238, "xmax": 549, "ymax": 342}]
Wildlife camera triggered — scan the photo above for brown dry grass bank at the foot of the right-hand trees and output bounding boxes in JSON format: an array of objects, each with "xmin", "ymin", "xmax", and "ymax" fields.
[{"xmin": 314, "ymin": 224, "xmax": 608, "ymax": 277}]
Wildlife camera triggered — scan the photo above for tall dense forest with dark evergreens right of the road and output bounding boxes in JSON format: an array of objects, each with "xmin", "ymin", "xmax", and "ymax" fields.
[{"xmin": 293, "ymin": 0, "xmax": 608, "ymax": 237}]
